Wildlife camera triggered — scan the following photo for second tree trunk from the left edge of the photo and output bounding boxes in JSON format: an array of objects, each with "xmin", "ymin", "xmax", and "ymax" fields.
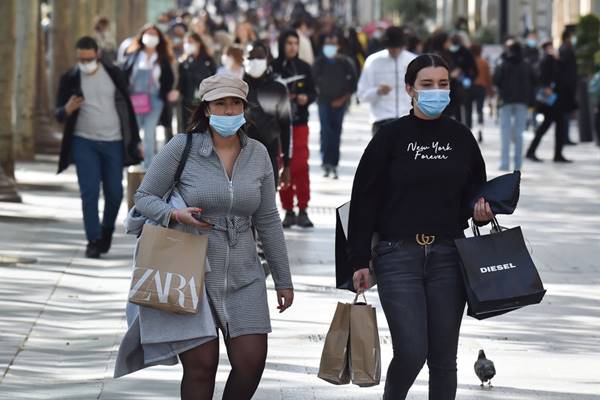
[{"xmin": 14, "ymin": 0, "xmax": 40, "ymax": 160}]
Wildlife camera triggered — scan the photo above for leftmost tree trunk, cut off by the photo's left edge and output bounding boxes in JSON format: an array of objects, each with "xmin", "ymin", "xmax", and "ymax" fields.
[{"xmin": 0, "ymin": 0, "xmax": 16, "ymax": 178}]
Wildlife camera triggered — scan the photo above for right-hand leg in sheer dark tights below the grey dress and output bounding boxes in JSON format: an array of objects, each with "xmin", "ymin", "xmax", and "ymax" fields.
[{"xmin": 223, "ymin": 334, "xmax": 267, "ymax": 400}]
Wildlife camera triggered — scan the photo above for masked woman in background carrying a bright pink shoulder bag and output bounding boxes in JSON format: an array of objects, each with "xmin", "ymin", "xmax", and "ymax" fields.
[{"xmin": 123, "ymin": 25, "xmax": 177, "ymax": 169}]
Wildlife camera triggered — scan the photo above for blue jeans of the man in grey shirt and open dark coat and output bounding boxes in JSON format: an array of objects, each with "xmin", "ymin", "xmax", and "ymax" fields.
[{"xmin": 71, "ymin": 136, "xmax": 123, "ymax": 241}]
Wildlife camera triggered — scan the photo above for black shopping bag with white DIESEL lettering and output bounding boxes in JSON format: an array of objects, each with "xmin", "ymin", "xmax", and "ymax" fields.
[{"xmin": 455, "ymin": 220, "xmax": 546, "ymax": 320}]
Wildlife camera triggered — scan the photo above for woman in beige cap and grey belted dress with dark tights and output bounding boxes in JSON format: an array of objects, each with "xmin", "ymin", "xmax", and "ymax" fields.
[{"xmin": 115, "ymin": 75, "xmax": 294, "ymax": 400}]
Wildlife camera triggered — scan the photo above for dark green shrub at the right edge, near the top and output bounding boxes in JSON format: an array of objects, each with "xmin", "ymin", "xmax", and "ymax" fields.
[{"xmin": 575, "ymin": 14, "xmax": 600, "ymax": 77}]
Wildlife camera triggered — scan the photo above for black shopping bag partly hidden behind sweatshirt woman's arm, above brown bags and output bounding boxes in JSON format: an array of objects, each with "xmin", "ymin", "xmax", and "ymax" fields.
[{"xmin": 335, "ymin": 201, "xmax": 378, "ymax": 292}]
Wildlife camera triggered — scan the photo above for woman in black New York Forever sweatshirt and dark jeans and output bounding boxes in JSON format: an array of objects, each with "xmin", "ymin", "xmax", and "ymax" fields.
[{"xmin": 348, "ymin": 54, "xmax": 493, "ymax": 400}]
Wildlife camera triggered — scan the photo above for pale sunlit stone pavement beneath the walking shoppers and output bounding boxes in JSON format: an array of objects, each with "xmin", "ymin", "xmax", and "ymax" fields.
[{"xmin": 0, "ymin": 106, "xmax": 600, "ymax": 400}]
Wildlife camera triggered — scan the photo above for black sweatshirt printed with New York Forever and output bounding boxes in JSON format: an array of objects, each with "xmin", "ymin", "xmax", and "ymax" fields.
[{"xmin": 348, "ymin": 111, "xmax": 486, "ymax": 269}]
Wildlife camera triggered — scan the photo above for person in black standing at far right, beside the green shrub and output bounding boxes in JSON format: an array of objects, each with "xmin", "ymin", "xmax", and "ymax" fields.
[{"xmin": 558, "ymin": 29, "xmax": 578, "ymax": 144}]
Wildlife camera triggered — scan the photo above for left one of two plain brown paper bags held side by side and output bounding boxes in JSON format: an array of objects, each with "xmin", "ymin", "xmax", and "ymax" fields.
[{"xmin": 318, "ymin": 303, "xmax": 352, "ymax": 385}]
